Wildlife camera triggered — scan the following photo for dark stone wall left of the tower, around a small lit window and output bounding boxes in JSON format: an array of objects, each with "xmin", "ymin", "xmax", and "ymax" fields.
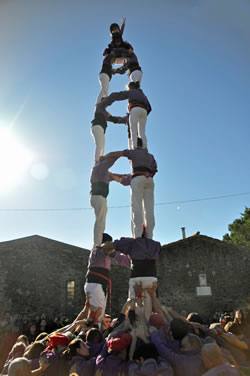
[{"xmin": 0, "ymin": 236, "xmax": 89, "ymax": 315}]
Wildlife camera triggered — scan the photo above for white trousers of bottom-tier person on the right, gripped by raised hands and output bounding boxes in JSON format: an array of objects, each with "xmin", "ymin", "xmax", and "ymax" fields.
[{"xmin": 128, "ymin": 277, "xmax": 157, "ymax": 321}]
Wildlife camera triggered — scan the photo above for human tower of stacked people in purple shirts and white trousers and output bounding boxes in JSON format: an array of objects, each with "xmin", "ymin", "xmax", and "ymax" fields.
[{"xmin": 85, "ymin": 19, "xmax": 161, "ymax": 322}]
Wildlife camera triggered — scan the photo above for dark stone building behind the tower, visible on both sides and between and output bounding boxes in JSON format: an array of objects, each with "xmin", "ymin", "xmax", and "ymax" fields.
[{"xmin": 0, "ymin": 235, "xmax": 250, "ymax": 317}]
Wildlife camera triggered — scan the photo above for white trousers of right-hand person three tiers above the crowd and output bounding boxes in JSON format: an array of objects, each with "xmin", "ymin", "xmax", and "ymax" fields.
[{"xmin": 129, "ymin": 107, "xmax": 147, "ymax": 149}]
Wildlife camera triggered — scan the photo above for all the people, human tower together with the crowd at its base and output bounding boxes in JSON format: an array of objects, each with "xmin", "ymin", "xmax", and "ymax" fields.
[{"xmin": 0, "ymin": 19, "xmax": 250, "ymax": 376}]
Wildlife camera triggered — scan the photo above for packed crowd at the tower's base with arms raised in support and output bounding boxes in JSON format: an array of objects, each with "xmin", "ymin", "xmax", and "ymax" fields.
[{"xmin": 1, "ymin": 296, "xmax": 250, "ymax": 376}]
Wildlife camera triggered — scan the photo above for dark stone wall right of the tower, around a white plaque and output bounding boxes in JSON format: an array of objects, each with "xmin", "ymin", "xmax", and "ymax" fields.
[{"xmin": 158, "ymin": 236, "xmax": 250, "ymax": 317}]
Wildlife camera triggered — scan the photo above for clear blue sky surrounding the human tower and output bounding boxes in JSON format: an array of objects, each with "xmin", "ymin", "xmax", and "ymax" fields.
[{"xmin": 0, "ymin": 0, "xmax": 250, "ymax": 248}]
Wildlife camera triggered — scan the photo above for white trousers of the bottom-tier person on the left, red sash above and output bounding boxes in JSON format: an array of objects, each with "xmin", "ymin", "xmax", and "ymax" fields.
[{"xmin": 84, "ymin": 282, "xmax": 108, "ymax": 321}]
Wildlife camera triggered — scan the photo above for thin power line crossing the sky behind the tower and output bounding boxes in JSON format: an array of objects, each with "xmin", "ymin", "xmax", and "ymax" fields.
[{"xmin": 0, "ymin": 192, "xmax": 250, "ymax": 212}]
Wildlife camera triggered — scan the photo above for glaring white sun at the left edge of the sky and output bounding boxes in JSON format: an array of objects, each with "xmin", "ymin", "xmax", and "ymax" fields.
[{"xmin": 0, "ymin": 128, "xmax": 32, "ymax": 193}]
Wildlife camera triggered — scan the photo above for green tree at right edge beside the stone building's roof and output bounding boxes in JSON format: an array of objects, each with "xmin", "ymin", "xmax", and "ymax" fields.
[{"xmin": 223, "ymin": 207, "xmax": 250, "ymax": 249}]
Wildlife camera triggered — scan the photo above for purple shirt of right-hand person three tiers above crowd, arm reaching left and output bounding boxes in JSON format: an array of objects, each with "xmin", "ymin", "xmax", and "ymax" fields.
[{"xmin": 102, "ymin": 89, "xmax": 151, "ymax": 114}]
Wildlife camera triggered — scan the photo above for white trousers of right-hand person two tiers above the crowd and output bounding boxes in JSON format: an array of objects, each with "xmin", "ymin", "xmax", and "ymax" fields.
[{"xmin": 130, "ymin": 175, "xmax": 155, "ymax": 239}]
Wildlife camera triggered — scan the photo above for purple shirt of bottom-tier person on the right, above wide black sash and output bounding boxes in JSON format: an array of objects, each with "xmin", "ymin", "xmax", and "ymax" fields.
[{"xmin": 114, "ymin": 238, "xmax": 161, "ymax": 260}]
